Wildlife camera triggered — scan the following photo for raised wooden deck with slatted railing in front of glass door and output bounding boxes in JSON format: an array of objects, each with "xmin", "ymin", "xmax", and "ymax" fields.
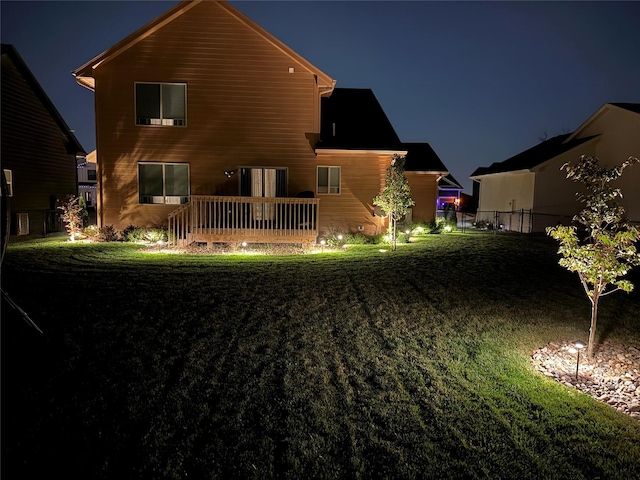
[{"xmin": 169, "ymin": 195, "xmax": 319, "ymax": 246}]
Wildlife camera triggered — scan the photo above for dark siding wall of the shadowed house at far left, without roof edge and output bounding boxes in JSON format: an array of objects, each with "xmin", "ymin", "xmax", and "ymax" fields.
[{"xmin": 0, "ymin": 50, "xmax": 77, "ymax": 234}]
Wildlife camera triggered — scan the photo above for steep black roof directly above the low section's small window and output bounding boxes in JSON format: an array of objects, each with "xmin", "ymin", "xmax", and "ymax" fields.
[{"xmin": 316, "ymin": 88, "xmax": 404, "ymax": 151}]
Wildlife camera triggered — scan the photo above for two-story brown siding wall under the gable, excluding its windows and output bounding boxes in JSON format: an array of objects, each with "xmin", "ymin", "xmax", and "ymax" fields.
[{"xmin": 94, "ymin": 2, "xmax": 322, "ymax": 229}]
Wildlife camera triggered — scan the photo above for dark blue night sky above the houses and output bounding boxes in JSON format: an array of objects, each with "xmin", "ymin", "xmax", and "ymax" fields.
[{"xmin": 0, "ymin": 0, "xmax": 640, "ymax": 194}]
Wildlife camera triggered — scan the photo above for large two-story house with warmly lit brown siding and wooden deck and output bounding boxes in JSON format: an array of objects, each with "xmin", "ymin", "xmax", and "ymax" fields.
[{"xmin": 73, "ymin": 0, "xmax": 450, "ymax": 243}]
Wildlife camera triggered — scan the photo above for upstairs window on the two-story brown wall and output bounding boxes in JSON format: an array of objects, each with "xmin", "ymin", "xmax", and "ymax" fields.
[{"xmin": 135, "ymin": 83, "xmax": 187, "ymax": 127}]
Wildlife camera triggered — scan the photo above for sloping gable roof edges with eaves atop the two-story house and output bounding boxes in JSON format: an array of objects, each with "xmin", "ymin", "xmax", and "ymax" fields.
[{"xmin": 71, "ymin": 0, "xmax": 336, "ymax": 92}]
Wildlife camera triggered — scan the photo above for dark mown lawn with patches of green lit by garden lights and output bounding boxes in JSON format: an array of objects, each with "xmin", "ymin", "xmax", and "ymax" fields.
[{"xmin": 2, "ymin": 234, "xmax": 640, "ymax": 479}]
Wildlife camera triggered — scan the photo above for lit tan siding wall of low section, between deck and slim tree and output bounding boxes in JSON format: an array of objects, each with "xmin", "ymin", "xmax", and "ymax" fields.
[{"xmin": 311, "ymin": 150, "xmax": 392, "ymax": 236}]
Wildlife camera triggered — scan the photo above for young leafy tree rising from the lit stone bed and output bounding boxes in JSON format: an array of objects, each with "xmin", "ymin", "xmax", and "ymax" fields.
[{"xmin": 547, "ymin": 155, "xmax": 640, "ymax": 358}]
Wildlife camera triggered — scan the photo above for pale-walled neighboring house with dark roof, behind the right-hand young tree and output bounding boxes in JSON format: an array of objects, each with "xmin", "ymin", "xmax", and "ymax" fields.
[{"xmin": 471, "ymin": 103, "xmax": 640, "ymax": 232}]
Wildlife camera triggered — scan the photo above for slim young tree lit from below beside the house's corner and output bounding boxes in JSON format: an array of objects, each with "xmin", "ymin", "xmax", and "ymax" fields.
[{"xmin": 373, "ymin": 155, "xmax": 415, "ymax": 250}]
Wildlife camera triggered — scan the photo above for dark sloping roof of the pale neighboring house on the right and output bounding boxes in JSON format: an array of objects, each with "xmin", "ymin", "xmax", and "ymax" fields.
[{"xmin": 471, "ymin": 134, "xmax": 594, "ymax": 177}]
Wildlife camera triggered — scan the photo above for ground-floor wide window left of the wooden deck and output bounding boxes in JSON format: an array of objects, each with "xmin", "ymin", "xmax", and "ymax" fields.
[{"xmin": 138, "ymin": 163, "xmax": 189, "ymax": 204}]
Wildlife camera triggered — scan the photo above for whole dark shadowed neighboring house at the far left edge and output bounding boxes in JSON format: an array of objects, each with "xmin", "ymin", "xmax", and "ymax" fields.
[{"xmin": 0, "ymin": 44, "xmax": 85, "ymax": 235}]
